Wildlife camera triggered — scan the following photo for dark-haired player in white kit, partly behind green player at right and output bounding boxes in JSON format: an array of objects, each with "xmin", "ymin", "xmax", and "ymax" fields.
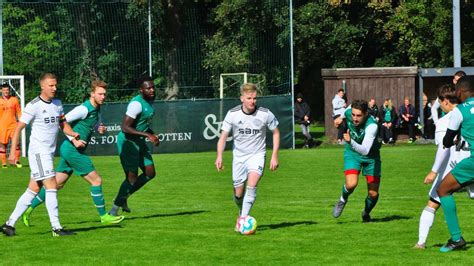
[{"xmin": 414, "ymin": 85, "xmax": 470, "ymax": 249}]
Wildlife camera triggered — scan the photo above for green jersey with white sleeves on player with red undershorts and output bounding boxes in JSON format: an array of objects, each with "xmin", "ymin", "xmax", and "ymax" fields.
[{"xmin": 344, "ymin": 108, "xmax": 380, "ymax": 157}]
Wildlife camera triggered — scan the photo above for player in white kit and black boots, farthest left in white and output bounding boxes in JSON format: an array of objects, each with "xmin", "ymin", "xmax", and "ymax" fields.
[{"xmin": 2, "ymin": 73, "xmax": 79, "ymax": 236}]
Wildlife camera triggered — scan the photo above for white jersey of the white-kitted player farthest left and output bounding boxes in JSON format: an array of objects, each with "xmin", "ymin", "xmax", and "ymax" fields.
[{"xmin": 20, "ymin": 97, "xmax": 64, "ymax": 154}]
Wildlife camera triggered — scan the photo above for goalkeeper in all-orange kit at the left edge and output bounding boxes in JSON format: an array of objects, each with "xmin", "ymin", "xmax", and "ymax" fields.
[{"xmin": 0, "ymin": 83, "xmax": 22, "ymax": 168}]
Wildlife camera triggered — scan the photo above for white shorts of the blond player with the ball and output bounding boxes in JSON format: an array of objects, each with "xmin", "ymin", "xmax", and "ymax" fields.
[{"xmin": 232, "ymin": 152, "xmax": 265, "ymax": 187}]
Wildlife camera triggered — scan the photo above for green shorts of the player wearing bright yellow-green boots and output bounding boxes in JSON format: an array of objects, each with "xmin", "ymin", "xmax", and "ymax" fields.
[{"xmin": 56, "ymin": 140, "xmax": 95, "ymax": 176}]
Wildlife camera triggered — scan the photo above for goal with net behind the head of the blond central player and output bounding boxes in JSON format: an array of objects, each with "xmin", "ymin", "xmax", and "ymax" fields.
[{"xmin": 219, "ymin": 72, "xmax": 267, "ymax": 99}]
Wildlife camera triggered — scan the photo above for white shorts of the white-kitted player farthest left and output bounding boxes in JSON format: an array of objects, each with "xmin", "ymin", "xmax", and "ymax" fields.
[{"xmin": 28, "ymin": 153, "xmax": 56, "ymax": 181}]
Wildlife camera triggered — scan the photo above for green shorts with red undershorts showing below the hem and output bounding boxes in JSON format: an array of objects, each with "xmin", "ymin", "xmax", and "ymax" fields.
[{"xmin": 344, "ymin": 151, "xmax": 382, "ymax": 180}]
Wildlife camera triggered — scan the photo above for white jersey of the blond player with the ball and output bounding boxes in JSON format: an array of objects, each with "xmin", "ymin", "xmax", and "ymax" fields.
[{"xmin": 222, "ymin": 105, "xmax": 278, "ymax": 158}]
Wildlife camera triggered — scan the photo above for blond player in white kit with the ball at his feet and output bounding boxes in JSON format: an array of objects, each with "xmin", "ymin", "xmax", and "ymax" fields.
[{"xmin": 215, "ymin": 83, "xmax": 280, "ymax": 231}]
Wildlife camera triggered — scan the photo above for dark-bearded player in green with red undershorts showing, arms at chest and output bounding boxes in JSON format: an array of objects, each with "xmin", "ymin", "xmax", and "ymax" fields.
[{"xmin": 333, "ymin": 100, "xmax": 381, "ymax": 222}]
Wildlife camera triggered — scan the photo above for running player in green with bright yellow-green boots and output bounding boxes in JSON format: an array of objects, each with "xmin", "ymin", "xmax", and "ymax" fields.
[{"xmin": 22, "ymin": 80, "xmax": 124, "ymax": 226}]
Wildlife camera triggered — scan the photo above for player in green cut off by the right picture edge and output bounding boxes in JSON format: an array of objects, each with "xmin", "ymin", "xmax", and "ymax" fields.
[{"xmin": 438, "ymin": 77, "xmax": 474, "ymax": 252}]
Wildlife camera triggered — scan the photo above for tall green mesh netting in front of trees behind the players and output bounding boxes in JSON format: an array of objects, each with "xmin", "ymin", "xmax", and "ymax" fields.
[{"xmin": 2, "ymin": 0, "xmax": 290, "ymax": 103}]
